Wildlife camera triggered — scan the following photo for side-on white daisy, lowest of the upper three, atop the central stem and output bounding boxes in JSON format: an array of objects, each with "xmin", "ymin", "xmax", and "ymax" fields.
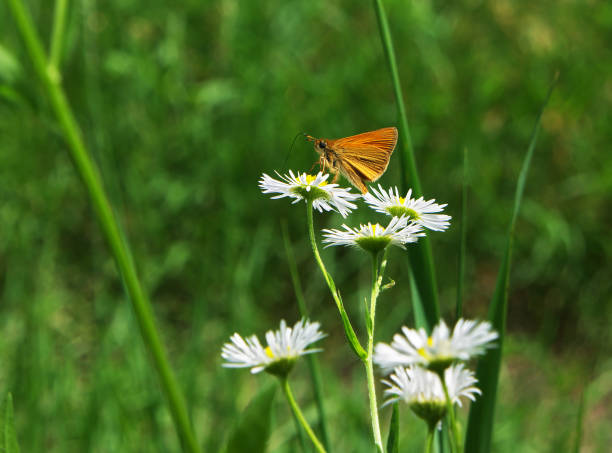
[{"xmin": 323, "ymin": 216, "xmax": 425, "ymax": 253}]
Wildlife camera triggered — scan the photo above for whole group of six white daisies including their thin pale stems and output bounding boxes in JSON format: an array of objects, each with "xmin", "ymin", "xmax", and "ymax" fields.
[{"xmin": 221, "ymin": 170, "xmax": 490, "ymax": 446}]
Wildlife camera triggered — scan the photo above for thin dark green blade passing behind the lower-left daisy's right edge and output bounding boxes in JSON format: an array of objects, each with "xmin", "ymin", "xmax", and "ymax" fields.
[{"xmin": 281, "ymin": 222, "xmax": 331, "ymax": 453}]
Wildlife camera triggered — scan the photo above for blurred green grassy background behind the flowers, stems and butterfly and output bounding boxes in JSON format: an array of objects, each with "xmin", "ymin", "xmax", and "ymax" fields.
[{"xmin": 0, "ymin": 0, "xmax": 612, "ymax": 452}]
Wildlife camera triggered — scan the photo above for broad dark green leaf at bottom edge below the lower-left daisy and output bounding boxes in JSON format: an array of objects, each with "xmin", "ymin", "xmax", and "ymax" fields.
[{"xmin": 222, "ymin": 384, "xmax": 276, "ymax": 453}]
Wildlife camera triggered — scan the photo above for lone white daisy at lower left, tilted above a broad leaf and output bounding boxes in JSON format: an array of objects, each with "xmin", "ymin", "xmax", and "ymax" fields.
[{"xmin": 221, "ymin": 319, "xmax": 326, "ymax": 376}]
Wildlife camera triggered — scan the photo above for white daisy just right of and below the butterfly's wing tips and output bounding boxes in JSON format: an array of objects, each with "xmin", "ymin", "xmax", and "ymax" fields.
[{"xmin": 363, "ymin": 184, "xmax": 451, "ymax": 231}]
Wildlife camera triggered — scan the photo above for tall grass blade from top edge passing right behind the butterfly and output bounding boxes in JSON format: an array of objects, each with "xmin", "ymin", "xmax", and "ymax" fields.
[{"xmin": 374, "ymin": 0, "xmax": 440, "ymax": 326}]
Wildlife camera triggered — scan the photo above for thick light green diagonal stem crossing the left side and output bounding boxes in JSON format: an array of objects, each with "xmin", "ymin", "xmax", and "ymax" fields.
[{"xmin": 8, "ymin": 0, "xmax": 200, "ymax": 452}]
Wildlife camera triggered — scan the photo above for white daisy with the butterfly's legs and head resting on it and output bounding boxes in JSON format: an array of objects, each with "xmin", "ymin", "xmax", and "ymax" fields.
[{"xmin": 259, "ymin": 170, "xmax": 360, "ymax": 217}]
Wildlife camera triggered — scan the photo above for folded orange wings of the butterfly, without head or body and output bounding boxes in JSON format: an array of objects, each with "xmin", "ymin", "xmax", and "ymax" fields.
[{"xmin": 329, "ymin": 127, "xmax": 397, "ymax": 182}]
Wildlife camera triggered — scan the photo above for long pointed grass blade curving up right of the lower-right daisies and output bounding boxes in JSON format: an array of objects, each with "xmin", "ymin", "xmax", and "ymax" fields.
[{"xmin": 465, "ymin": 72, "xmax": 557, "ymax": 453}]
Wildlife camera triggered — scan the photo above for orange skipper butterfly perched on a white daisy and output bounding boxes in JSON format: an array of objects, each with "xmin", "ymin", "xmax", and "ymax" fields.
[{"xmin": 306, "ymin": 127, "xmax": 397, "ymax": 193}]
